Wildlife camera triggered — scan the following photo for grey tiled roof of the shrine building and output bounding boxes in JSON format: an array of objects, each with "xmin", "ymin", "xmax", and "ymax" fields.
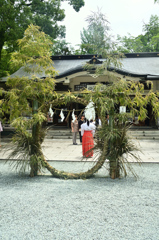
[{"xmin": 3, "ymin": 53, "xmax": 159, "ymax": 81}]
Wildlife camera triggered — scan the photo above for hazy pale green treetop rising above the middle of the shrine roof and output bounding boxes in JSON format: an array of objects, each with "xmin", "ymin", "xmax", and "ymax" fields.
[{"xmin": 80, "ymin": 9, "xmax": 112, "ymax": 54}]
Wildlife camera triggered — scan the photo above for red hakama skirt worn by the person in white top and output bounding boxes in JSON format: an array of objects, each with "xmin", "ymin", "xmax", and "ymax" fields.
[{"xmin": 82, "ymin": 131, "xmax": 94, "ymax": 157}]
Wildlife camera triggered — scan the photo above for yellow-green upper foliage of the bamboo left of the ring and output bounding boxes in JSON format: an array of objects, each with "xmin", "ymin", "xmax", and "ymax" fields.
[{"xmin": 2, "ymin": 24, "xmax": 56, "ymax": 122}]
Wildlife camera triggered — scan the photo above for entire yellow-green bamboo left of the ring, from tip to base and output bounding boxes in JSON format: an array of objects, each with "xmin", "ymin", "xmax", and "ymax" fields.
[{"xmin": 1, "ymin": 25, "xmax": 56, "ymax": 176}]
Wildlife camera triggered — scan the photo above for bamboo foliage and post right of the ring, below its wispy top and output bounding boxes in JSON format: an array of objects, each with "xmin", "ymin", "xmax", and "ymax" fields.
[{"xmin": 81, "ymin": 79, "xmax": 159, "ymax": 179}]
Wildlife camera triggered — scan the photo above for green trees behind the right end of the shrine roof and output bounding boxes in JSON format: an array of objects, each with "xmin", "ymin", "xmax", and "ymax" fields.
[{"xmin": 117, "ymin": 15, "xmax": 159, "ymax": 52}]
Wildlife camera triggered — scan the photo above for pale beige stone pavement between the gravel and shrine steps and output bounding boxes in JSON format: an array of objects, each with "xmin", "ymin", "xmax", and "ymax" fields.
[{"xmin": 0, "ymin": 139, "xmax": 159, "ymax": 163}]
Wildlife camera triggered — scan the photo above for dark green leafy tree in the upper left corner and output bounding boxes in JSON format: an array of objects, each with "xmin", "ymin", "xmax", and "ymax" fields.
[{"xmin": 0, "ymin": 0, "xmax": 84, "ymax": 76}]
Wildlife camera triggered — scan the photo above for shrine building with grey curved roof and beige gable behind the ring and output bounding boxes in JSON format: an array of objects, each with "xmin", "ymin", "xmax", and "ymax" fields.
[{"xmin": 0, "ymin": 52, "xmax": 159, "ymax": 126}]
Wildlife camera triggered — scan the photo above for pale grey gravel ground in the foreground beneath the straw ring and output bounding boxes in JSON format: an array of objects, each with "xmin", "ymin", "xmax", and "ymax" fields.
[{"xmin": 0, "ymin": 161, "xmax": 159, "ymax": 240}]
